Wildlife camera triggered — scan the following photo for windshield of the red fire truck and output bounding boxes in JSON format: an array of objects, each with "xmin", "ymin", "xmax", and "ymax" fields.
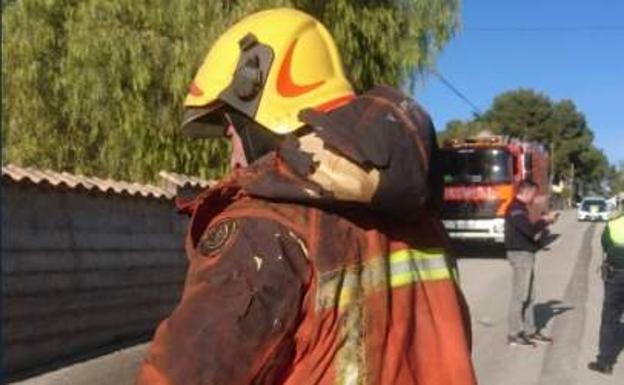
[{"xmin": 443, "ymin": 148, "xmax": 513, "ymax": 185}]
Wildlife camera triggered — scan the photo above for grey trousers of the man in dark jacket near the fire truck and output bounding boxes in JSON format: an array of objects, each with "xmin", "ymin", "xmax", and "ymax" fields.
[{"xmin": 507, "ymin": 250, "xmax": 536, "ymax": 336}]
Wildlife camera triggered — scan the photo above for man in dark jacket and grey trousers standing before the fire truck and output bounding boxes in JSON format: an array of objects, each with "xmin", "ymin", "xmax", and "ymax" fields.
[{"xmin": 505, "ymin": 180, "xmax": 557, "ymax": 347}]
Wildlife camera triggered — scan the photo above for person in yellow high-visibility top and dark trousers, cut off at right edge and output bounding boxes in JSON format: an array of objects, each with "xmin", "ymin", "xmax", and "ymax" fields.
[{"xmin": 588, "ymin": 216, "xmax": 624, "ymax": 374}]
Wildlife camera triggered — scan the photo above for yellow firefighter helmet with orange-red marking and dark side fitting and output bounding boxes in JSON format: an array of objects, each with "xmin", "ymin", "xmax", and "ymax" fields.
[{"xmin": 182, "ymin": 8, "xmax": 353, "ymax": 136}]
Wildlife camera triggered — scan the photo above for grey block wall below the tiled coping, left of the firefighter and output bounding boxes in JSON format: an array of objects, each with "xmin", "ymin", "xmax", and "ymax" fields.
[{"xmin": 2, "ymin": 181, "xmax": 186, "ymax": 375}]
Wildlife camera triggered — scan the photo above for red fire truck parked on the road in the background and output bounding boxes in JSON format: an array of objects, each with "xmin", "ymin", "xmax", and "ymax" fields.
[{"xmin": 442, "ymin": 135, "xmax": 550, "ymax": 243}]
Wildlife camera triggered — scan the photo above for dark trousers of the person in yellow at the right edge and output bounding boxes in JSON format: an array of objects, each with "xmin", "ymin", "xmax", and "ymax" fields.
[{"xmin": 598, "ymin": 270, "xmax": 624, "ymax": 365}]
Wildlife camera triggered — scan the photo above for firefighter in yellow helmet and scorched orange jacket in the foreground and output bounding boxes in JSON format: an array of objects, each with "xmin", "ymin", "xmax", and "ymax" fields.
[{"xmin": 137, "ymin": 9, "xmax": 475, "ymax": 385}]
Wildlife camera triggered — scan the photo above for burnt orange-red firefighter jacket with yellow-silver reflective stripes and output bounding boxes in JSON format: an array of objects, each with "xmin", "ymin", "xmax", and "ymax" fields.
[{"xmin": 138, "ymin": 88, "xmax": 476, "ymax": 385}]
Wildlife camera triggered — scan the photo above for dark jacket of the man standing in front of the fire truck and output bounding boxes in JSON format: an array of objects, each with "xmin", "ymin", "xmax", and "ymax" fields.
[{"xmin": 505, "ymin": 198, "xmax": 547, "ymax": 253}]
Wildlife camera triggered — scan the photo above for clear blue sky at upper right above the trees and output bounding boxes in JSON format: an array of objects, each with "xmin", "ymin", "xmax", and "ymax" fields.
[{"xmin": 414, "ymin": 0, "xmax": 624, "ymax": 164}]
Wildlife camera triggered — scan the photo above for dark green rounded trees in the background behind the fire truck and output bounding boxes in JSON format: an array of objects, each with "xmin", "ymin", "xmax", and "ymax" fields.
[{"xmin": 441, "ymin": 89, "xmax": 609, "ymax": 190}]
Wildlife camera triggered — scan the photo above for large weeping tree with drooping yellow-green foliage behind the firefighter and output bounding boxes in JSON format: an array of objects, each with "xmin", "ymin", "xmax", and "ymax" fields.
[{"xmin": 2, "ymin": 0, "xmax": 458, "ymax": 181}]
